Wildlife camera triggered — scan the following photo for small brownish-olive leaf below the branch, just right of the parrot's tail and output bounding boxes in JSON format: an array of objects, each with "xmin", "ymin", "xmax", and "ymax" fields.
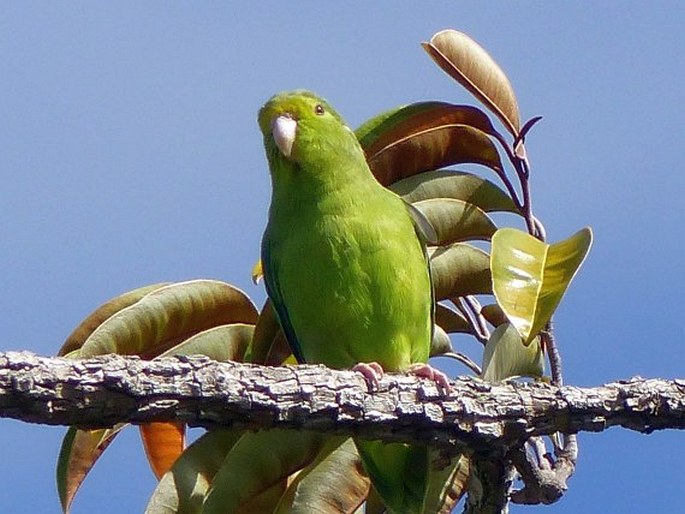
[{"xmin": 423, "ymin": 448, "xmax": 470, "ymax": 514}]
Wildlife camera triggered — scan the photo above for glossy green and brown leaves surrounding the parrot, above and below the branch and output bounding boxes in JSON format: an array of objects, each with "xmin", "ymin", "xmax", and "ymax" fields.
[{"xmin": 57, "ymin": 30, "xmax": 591, "ymax": 514}]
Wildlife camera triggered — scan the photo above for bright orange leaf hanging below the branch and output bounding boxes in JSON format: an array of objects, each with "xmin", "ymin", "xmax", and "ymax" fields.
[{"xmin": 139, "ymin": 422, "xmax": 186, "ymax": 480}]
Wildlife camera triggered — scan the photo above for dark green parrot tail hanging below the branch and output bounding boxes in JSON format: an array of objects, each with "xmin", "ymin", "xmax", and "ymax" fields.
[{"xmin": 354, "ymin": 439, "xmax": 428, "ymax": 514}]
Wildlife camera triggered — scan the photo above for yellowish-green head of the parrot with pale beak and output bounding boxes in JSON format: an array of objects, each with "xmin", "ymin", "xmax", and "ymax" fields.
[{"xmin": 258, "ymin": 90, "xmax": 363, "ymax": 171}]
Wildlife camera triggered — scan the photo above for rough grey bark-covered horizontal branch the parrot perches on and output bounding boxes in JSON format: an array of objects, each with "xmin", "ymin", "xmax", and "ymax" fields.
[{"xmin": 0, "ymin": 352, "xmax": 685, "ymax": 458}]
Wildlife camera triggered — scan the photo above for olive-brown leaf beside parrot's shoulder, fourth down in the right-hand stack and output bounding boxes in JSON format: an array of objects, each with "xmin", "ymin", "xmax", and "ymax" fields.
[{"xmin": 413, "ymin": 198, "xmax": 497, "ymax": 246}]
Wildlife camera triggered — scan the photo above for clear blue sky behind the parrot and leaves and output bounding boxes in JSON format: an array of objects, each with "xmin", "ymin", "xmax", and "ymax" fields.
[{"xmin": 0, "ymin": 1, "xmax": 685, "ymax": 514}]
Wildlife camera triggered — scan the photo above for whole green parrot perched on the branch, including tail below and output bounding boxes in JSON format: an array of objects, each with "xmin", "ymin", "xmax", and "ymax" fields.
[{"xmin": 259, "ymin": 90, "xmax": 449, "ymax": 514}]
